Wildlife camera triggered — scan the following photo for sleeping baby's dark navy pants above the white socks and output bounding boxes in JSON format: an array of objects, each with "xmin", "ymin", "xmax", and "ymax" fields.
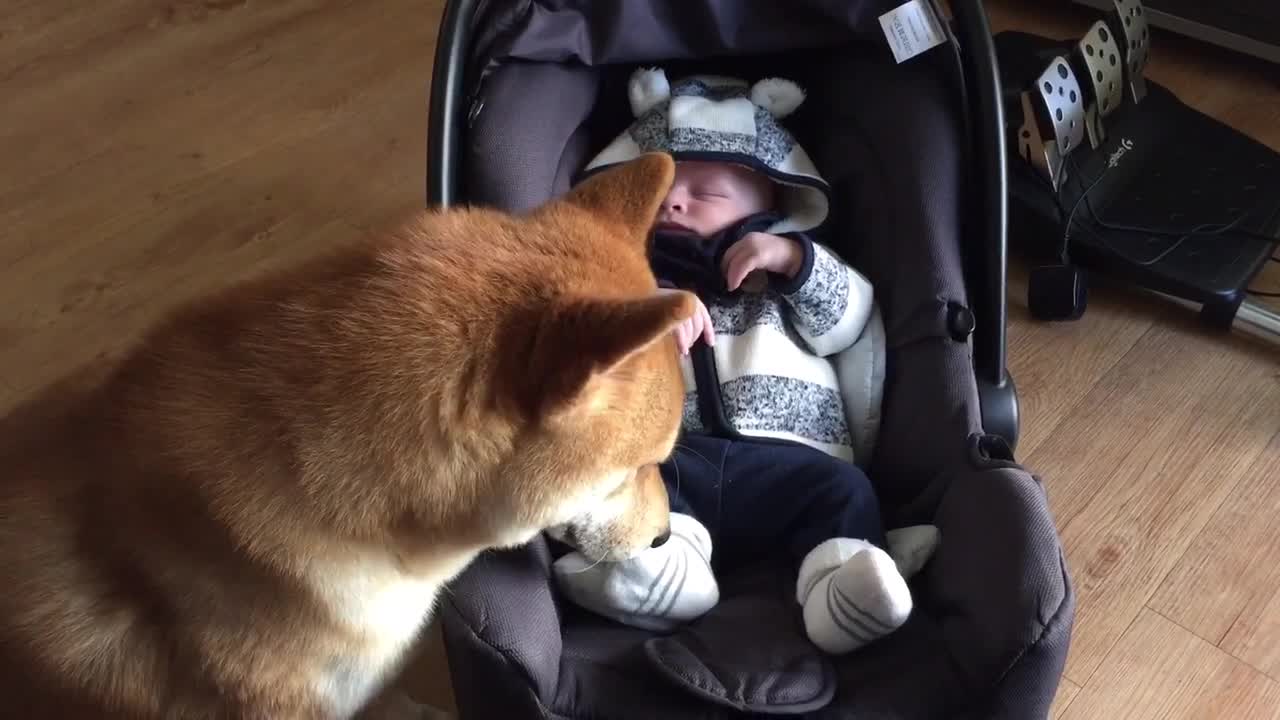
[{"xmin": 660, "ymin": 434, "xmax": 884, "ymax": 571}]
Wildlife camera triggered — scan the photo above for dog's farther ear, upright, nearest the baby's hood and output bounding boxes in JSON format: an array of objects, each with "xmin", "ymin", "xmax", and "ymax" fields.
[{"xmin": 562, "ymin": 152, "xmax": 676, "ymax": 237}]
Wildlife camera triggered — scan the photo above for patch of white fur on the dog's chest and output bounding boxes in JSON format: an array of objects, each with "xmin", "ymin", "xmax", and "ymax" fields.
[{"xmin": 308, "ymin": 553, "xmax": 456, "ymax": 716}]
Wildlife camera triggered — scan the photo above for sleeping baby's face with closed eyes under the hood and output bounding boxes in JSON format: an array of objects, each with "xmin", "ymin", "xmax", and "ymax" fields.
[{"xmin": 657, "ymin": 161, "xmax": 773, "ymax": 237}]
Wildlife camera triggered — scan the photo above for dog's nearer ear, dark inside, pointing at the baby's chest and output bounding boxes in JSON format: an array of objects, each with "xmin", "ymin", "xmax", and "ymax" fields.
[{"xmin": 525, "ymin": 290, "xmax": 696, "ymax": 420}]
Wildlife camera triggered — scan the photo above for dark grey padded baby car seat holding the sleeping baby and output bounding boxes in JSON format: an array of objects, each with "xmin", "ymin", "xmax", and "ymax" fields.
[{"xmin": 428, "ymin": 0, "xmax": 1075, "ymax": 720}]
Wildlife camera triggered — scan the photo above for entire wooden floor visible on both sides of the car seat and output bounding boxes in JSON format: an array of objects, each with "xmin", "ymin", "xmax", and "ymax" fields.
[{"xmin": 0, "ymin": 0, "xmax": 1280, "ymax": 720}]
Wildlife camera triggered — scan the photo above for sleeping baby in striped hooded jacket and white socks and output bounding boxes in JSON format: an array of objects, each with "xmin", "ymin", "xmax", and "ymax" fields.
[{"xmin": 554, "ymin": 70, "xmax": 938, "ymax": 653}]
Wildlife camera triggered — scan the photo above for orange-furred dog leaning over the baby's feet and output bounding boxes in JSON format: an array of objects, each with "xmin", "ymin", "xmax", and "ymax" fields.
[{"xmin": 0, "ymin": 155, "xmax": 694, "ymax": 719}]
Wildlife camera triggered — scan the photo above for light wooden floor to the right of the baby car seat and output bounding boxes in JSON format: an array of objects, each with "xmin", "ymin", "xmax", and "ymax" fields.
[{"xmin": 987, "ymin": 0, "xmax": 1280, "ymax": 720}]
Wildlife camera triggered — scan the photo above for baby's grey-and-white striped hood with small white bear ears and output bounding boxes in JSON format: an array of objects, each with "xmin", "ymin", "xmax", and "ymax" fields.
[{"xmin": 584, "ymin": 68, "xmax": 831, "ymax": 233}]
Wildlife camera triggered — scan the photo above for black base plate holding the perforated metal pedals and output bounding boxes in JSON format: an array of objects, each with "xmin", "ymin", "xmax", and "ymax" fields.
[{"xmin": 996, "ymin": 31, "xmax": 1280, "ymax": 315}]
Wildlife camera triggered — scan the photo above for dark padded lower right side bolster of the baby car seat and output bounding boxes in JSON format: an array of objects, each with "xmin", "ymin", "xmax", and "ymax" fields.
[{"xmin": 818, "ymin": 462, "xmax": 1074, "ymax": 719}]
